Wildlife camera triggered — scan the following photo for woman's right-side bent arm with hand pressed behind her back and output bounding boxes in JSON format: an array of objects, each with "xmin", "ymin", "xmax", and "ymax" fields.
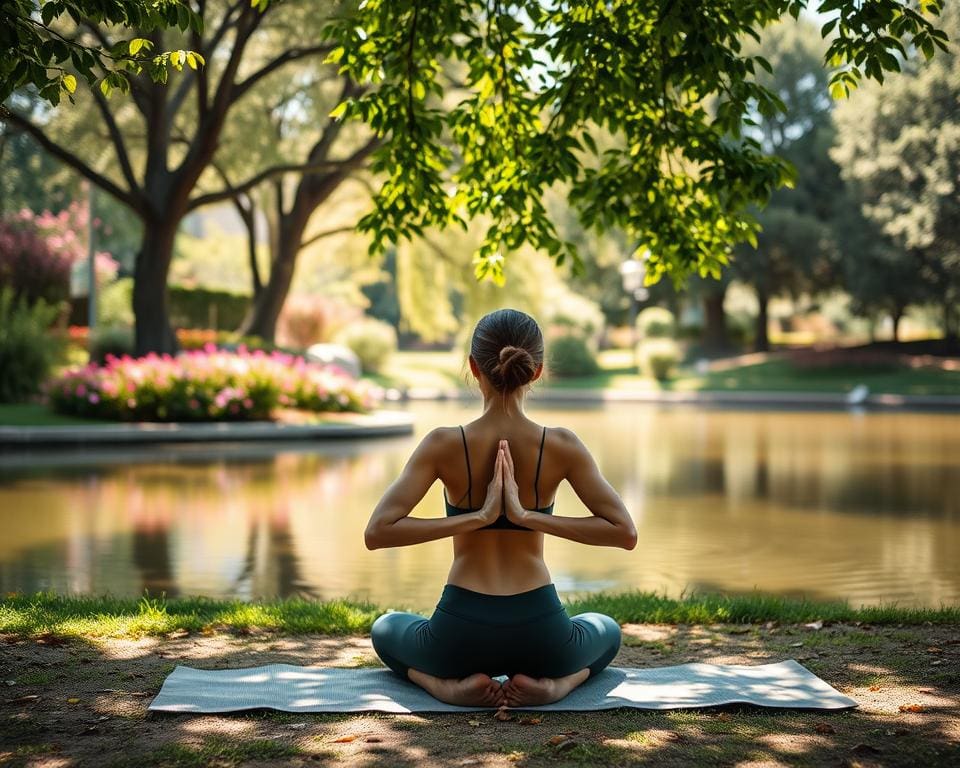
[{"xmin": 504, "ymin": 429, "xmax": 637, "ymax": 549}]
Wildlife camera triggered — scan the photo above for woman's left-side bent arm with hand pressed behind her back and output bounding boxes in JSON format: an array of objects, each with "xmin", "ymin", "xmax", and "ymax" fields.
[{"xmin": 363, "ymin": 429, "xmax": 502, "ymax": 549}]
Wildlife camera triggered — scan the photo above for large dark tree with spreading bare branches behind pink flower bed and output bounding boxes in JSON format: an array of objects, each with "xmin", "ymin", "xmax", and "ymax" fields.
[{"xmin": 4, "ymin": 0, "xmax": 348, "ymax": 354}]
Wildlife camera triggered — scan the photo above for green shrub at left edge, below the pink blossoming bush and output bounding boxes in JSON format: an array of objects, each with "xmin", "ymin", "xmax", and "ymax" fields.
[{"xmin": 0, "ymin": 286, "xmax": 62, "ymax": 403}]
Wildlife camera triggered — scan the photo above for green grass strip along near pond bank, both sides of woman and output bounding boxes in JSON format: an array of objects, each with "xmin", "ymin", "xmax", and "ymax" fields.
[{"xmin": 0, "ymin": 591, "xmax": 960, "ymax": 639}]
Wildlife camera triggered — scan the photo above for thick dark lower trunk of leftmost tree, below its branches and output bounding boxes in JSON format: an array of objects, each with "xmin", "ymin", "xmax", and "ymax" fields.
[{"xmin": 133, "ymin": 216, "xmax": 180, "ymax": 356}]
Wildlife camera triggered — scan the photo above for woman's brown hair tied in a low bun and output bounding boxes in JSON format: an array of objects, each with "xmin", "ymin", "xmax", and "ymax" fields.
[{"xmin": 470, "ymin": 309, "xmax": 543, "ymax": 393}]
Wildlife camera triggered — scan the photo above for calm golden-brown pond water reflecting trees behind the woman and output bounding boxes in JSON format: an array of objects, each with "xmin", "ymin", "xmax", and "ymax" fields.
[{"xmin": 0, "ymin": 403, "xmax": 960, "ymax": 609}]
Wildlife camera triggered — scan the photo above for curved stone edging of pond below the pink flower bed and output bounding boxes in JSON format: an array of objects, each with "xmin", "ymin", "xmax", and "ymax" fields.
[{"xmin": 0, "ymin": 411, "xmax": 413, "ymax": 447}]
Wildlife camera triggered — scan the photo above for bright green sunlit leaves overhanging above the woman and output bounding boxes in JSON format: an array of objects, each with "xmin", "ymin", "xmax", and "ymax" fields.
[{"xmin": 331, "ymin": 0, "xmax": 946, "ymax": 292}]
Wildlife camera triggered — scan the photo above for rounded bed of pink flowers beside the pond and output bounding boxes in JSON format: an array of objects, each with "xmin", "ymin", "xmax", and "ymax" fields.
[{"xmin": 47, "ymin": 344, "xmax": 380, "ymax": 421}]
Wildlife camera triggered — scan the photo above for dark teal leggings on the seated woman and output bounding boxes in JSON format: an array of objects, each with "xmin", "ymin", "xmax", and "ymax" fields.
[{"xmin": 370, "ymin": 584, "xmax": 620, "ymax": 679}]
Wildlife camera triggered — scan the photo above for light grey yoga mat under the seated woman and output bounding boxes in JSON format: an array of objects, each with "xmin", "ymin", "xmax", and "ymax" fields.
[{"xmin": 149, "ymin": 659, "xmax": 857, "ymax": 713}]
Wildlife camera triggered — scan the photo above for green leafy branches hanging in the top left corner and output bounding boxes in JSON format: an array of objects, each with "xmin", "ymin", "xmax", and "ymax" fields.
[{"xmin": 0, "ymin": 0, "xmax": 203, "ymax": 105}]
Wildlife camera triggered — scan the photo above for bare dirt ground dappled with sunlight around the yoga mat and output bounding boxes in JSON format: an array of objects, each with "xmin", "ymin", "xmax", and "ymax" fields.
[{"xmin": 0, "ymin": 623, "xmax": 960, "ymax": 768}]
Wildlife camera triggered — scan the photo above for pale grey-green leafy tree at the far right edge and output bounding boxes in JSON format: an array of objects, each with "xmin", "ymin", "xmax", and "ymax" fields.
[{"xmin": 832, "ymin": 6, "xmax": 960, "ymax": 337}]
